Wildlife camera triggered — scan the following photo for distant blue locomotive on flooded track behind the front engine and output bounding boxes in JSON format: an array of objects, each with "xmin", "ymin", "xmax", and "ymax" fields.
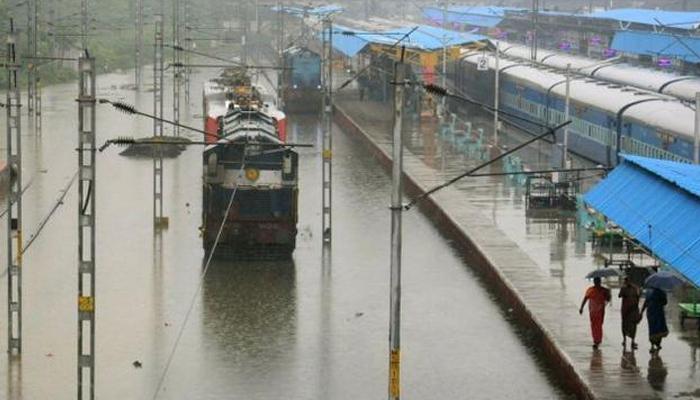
[{"xmin": 280, "ymin": 46, "xmax": 322, "ymax": 113}]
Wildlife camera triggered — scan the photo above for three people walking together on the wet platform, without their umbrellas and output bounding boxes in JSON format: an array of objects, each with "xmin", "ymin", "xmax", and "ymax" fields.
[{"xmin": 579, "ymin": 277, "xmax": 668, "ymax": 353}]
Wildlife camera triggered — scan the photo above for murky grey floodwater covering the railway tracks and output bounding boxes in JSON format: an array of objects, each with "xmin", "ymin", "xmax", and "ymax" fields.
[{"xmin": 0, "ymin": 67, "xmax": 563, "ymax": 400}]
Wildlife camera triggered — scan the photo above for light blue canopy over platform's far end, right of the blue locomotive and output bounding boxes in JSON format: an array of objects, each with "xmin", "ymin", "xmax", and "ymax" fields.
[{"xmin": 333, "ymin": 25, "xmax": 487, "ymax": 57}]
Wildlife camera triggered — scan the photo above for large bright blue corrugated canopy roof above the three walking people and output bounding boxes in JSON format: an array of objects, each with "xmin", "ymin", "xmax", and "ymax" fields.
[{"xmin": 584, "ymin": 155, "xmax": 700, "ymax": 286}]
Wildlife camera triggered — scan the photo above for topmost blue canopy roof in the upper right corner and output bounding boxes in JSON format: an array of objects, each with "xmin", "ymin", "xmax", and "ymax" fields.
[{"xmin": 589, "ymin": 8, "xmax": 700, "ymax": 29}]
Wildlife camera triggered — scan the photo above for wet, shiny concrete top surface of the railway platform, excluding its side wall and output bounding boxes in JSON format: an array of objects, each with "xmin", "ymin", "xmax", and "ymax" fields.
[{"xmin": 336, "ymin": 91, "xmax": 700, "ymax": 399}]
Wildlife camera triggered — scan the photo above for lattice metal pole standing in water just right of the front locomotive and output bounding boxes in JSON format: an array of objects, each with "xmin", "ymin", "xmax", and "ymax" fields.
[{"xmin": 321, "ymin": 17, "xmax": 333, "ymax": 243}]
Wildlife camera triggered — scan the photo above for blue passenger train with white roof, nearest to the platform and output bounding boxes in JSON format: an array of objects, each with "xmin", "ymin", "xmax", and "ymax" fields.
[{"xmin": 449, "ymin": 52, "xmax": 695, "ymax": 166}]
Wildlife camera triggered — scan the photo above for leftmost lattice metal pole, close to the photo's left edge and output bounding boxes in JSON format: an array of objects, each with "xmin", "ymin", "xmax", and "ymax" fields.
[{"xmin": 5, "ymin": 19, "xmax": 22, "ymax": 355}]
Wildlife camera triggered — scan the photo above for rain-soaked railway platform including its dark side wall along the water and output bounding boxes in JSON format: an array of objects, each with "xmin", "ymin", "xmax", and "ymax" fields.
[{"xmin": 335, "ymin": 94, "xmax": 700, "ymax": 399}]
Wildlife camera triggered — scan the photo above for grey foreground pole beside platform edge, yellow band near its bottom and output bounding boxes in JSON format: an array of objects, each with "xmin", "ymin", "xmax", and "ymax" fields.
[{"xmin": 389, "ymin": 57, "xmax": 405, "ymax": 400}]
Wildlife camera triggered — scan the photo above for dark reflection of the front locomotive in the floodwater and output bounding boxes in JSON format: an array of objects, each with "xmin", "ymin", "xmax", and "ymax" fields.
[{"xmin": 202, "ymin": 260, "xmax": 297, "ymax": 388}]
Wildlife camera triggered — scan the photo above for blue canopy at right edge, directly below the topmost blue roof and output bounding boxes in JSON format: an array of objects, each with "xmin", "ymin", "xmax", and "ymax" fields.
[{"xmin": 610, "ymin": 31, "xmax": 700, "ymax": 63}]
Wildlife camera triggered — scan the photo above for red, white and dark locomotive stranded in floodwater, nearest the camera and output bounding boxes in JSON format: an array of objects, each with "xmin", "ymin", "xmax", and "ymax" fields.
[{"xmin": 203, "ymin": 85, "xmax": 298, "ymax": 259}]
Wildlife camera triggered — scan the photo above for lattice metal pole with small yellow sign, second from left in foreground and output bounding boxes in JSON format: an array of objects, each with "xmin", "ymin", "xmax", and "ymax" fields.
[{"xmin": 78, "ymin": 54, "xmax": 97, "ymax": 400}]
